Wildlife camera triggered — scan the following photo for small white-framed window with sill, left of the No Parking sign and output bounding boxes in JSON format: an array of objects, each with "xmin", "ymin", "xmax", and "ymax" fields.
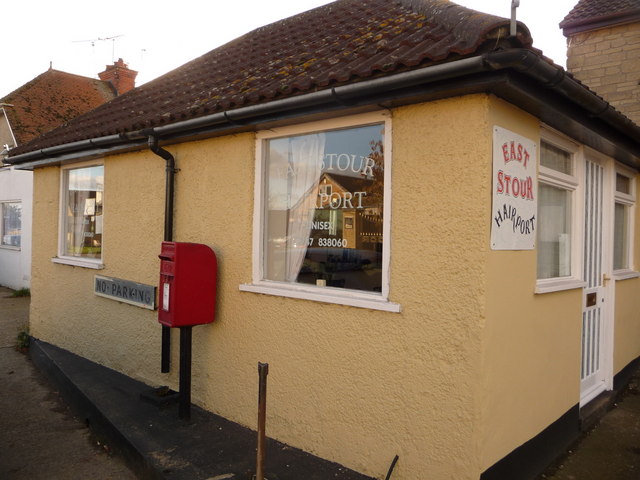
[{"xmin": 55, "ymin": 165, "xmax": 104, "ymax": 268}]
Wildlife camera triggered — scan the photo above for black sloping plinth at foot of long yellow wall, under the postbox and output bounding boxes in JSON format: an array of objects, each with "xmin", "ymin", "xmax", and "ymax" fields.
[{"xmin": 30, "ymin": 339, "xmax": 384, "ymax": 480}]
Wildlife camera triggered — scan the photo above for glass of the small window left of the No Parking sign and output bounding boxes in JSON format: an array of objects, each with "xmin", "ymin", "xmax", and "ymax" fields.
[{"xmin": 64, "ymin": 166, "xmax": 104, "ymax": 258}]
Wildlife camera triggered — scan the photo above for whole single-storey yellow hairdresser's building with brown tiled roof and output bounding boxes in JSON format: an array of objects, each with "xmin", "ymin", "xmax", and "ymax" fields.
[{"xmin": 3, "ymin": 0, "xmax": 640, "ymax": 480}]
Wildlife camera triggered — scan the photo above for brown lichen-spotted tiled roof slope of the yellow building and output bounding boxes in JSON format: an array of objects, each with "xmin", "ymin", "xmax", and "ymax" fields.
[{"xmin": 8, "ymin": 0, "xmax": 531, "ymax": 158}]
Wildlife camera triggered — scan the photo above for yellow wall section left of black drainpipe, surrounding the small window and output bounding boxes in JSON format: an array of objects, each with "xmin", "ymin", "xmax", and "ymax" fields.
[{"xmin": 31, "ymin": 152, "xmax": 164, "ymax": 381}]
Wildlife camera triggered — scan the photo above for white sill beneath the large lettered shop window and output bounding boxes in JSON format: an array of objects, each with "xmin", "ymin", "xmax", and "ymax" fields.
[{"xmin": 240, "ymin": 284, "xmax": 400, "ymax": 313}]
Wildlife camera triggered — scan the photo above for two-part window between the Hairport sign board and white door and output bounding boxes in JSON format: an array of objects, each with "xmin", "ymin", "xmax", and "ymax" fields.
[{"xmin": 537, "ymin": 140, "xmax": 578, "ymax": 284}]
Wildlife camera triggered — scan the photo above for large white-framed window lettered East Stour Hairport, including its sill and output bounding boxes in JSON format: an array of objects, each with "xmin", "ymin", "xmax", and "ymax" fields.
[{"xmin": 241, "ymin": 115, "xmax": 399, "ymax": 311}]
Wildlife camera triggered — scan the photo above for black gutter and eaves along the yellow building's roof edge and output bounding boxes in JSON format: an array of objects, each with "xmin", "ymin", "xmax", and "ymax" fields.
[{"xmin": 8, "ymin": 49, "xmax": 640, "ymax": 169}]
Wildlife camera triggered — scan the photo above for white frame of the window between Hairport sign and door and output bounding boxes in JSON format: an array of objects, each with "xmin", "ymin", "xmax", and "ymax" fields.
[{"xmin": 535, "ymin": 128, "xmax": 586, "ymax": 293}]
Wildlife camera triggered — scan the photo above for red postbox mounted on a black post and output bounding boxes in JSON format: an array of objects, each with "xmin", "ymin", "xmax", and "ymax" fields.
[{"xmin": 158, "ymin": 242, "xmax": 218, "ymax": 327}]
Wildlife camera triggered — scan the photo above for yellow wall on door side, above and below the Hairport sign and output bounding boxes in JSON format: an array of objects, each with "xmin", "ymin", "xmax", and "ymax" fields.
[{"xmin": 481, "ymin": 99, "xmax": 582, "ymax": 470}]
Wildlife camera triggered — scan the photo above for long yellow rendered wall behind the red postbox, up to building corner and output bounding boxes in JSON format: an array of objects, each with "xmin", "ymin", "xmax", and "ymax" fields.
[{"xmin": 27, "ymin": 96, "xmax": 491, "ymax": 480}]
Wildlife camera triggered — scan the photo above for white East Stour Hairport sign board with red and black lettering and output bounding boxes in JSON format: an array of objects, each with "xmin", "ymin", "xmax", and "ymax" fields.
[{"xmin": 491, "ymin": 127, "xmax": 538, "ymax": 250}]
